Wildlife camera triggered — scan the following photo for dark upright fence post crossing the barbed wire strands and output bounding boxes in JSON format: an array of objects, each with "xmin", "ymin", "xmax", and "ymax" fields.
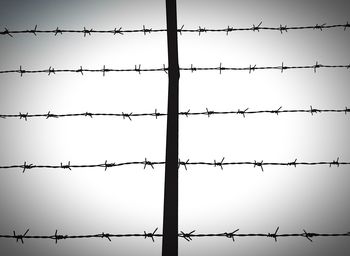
[{"xmin": 162, "ymin": 0, "xmax": 180, "ymax": 256}]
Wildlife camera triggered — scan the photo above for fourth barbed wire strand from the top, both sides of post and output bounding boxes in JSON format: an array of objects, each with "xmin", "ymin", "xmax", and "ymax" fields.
[{"xmin": 0, "ymin": 157, "xmax": 350, "ymax": 173}]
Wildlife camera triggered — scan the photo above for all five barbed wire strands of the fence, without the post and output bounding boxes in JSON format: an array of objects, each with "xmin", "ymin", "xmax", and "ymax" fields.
[{"xmin": 0, "ymin": 10, "xmax": 350, "ymax": 256}]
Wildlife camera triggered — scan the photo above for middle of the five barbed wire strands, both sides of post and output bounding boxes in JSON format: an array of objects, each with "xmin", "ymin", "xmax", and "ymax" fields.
[{"xmin": 0, "ymin": 106, "xmax": 350, "ymax": 121}]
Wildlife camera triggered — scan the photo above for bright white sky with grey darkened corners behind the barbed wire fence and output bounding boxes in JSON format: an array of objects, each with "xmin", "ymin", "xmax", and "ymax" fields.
[{"xmin": 0, "ymin": 0, "xmax": 350, "ymax": 256}]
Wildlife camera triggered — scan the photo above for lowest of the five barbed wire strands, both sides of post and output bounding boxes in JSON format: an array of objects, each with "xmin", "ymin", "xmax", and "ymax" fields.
[{"xmin": 0, "ymin": 227, "xmax": 350, "ymax": 244}]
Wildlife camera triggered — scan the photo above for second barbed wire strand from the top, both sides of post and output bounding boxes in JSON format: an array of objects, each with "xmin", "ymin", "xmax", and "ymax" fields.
[{"xmin": 0, "ymin": 61, "xmax": 350, "ymax": 77}]
